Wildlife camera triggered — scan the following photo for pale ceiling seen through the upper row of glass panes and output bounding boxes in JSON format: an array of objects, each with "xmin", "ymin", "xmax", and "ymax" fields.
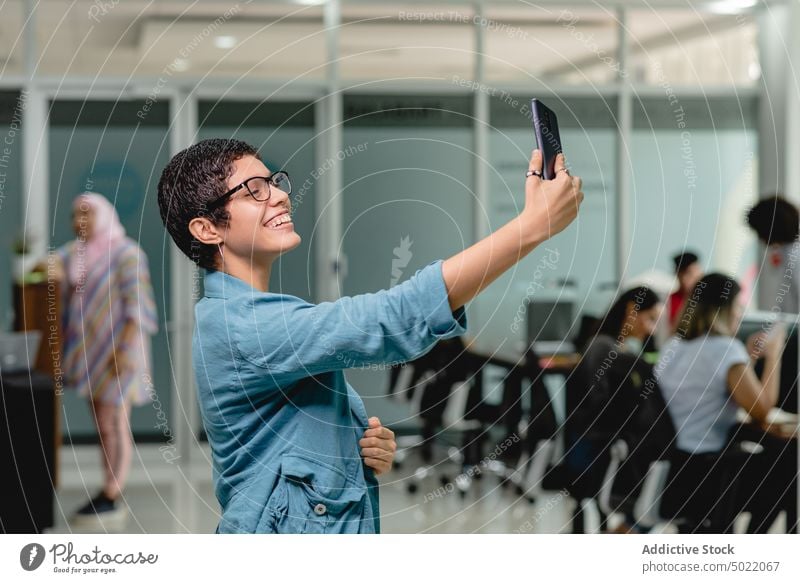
[{"xmin": 0, "ymin": 0, "xmax": 764, "ymax": 82}]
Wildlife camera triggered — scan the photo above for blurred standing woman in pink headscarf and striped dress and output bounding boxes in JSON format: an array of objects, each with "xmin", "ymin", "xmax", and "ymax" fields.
[{"xmin": 55, "ymin": 193, "xmax": 158, "ymax": 529}]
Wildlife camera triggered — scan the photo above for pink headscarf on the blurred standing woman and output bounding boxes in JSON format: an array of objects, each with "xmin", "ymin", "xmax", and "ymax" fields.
[{"xmin": 69, "ymin": 192, "xmax": 125, "ymax": 285}]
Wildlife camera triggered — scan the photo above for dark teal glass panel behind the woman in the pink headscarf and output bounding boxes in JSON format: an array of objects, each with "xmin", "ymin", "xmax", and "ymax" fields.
[{"xmin": 48, "ymin": 99, "xmax": 172, "ymax": 442}]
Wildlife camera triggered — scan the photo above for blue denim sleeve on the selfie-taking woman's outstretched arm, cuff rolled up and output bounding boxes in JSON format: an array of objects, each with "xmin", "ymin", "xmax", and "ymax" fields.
[{"xmin": 237, "ymin": 260, "xmax": 467, "ymax": 378}]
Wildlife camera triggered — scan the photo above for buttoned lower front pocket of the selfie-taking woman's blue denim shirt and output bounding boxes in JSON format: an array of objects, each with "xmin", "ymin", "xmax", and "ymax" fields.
[{"xmin": 257, "ymin": 453, "xmax": 367, "ymax": 534}]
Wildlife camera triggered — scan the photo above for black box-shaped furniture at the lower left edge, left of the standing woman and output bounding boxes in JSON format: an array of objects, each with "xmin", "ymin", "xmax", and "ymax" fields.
[{"xmin": 0, "ymin": 372, "xmax": 56, "ymax": 534}]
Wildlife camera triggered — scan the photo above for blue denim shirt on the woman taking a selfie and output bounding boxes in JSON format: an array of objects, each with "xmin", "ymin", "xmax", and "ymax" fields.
[{"xmin": 192, "ymin": 261, "xmax": 467, "ymax": 533}]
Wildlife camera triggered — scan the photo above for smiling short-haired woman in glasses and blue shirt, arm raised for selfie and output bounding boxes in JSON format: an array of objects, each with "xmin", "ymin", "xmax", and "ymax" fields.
[{"xmin": 158, "ymin": 139, "xmax": 583, "ymax": 533}]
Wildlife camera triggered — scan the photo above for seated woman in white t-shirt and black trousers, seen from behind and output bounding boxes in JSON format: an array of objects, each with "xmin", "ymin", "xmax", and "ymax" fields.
[{"xmin": 655, "ymin": 273, "xmax": 785, "ymax": 532}]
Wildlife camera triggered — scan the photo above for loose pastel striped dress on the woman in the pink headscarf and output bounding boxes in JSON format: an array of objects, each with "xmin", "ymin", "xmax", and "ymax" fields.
[{"xmin": 56, "ymin": 237, "xmax": 158, "ymax": 405}]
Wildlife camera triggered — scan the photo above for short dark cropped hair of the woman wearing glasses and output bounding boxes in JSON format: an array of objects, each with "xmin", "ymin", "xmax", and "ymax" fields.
[{"xmin": 158, "ymin": 138, "xmax": 261, "ymax": 269}]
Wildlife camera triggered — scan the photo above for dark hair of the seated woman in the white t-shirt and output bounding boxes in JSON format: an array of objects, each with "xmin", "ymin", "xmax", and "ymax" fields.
[{"xmin": 676, "ymin": 273, "xmax": 742, "ymax": 340}]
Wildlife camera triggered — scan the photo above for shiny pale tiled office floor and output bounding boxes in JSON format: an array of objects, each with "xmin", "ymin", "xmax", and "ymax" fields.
[{"xmin": 50, "ymin": 445, "xmax": 570, "ymax": 533}]
